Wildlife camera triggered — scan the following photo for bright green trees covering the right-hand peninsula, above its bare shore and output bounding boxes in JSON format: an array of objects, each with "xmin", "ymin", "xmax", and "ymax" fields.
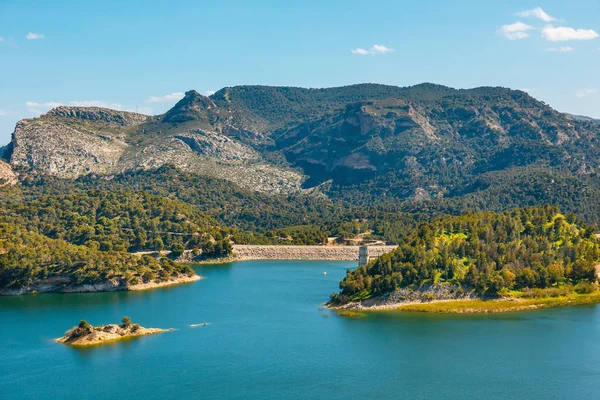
[{"xmin": 332, "ymin": 206, "xmax": 600, "ymax": 303}]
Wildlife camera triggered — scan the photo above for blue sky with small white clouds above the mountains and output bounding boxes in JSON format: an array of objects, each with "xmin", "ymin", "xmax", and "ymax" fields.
[{"xmin": 0, "ymin": 0, "xmax": 600, "ymax": 144}]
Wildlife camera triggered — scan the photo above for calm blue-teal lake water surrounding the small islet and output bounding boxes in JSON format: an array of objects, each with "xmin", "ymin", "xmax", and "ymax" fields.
[{"xmin": 0, "ymin": 261, "xmax": 600, "ymax": 400}]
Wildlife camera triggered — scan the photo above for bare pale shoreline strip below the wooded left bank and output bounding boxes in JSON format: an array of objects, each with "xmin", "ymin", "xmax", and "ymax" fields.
[{"xmin": 0, "ymin": 274, "xmax": 203, "ymax": 296}]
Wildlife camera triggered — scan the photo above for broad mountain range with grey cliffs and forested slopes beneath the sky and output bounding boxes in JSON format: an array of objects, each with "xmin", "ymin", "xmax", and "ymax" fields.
[{"xmin": 5, "ymin": 83, "xmax": 600, "ymax": 203}]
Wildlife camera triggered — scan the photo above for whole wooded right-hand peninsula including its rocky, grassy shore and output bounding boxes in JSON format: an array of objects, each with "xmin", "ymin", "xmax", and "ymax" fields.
[{"xmin": 328, "ymin": 206, "xmax": 600, "ymax": 313}]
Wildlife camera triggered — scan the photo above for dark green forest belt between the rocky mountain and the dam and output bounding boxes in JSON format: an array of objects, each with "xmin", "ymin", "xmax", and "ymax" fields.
[{"xmin": 14, "ymin": 166, "xmax": 429, "ymax": 244}]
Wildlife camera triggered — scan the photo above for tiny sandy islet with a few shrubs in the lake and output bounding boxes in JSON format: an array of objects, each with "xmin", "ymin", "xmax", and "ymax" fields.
[{"xmin": 56, "ymin": 317, "xmax": 168, "ymax": 346}]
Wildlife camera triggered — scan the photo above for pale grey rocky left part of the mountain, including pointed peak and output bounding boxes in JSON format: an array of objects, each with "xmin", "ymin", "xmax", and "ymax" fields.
[{"xmin": 10, "ymin": 105, "xmax": 303, "ymax": 193}]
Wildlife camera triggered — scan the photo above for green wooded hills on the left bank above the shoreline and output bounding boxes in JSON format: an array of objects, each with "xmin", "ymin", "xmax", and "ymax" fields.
[{"xmin": 0, "ymin": 191, "xmax": 209, "ymax": 289}]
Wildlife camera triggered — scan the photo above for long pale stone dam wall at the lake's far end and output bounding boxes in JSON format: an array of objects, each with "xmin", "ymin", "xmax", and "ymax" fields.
[{"xmin": 232, "ymin": 245, "xmax": 396, "ymax": 261}]
